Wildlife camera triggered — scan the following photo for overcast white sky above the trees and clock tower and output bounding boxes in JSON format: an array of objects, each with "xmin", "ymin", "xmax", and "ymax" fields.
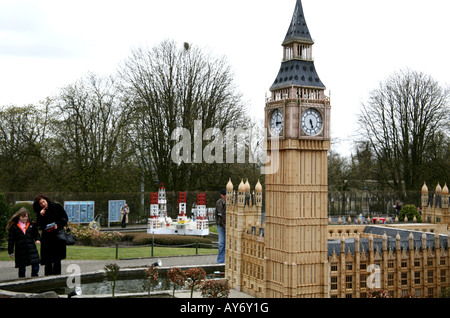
[{"xmin": 0, "ymin": 0, "xmax": 450, "ymax": 155}]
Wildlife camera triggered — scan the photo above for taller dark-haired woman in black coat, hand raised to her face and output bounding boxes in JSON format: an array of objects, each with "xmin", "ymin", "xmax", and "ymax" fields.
[{"xmin": 33, "ymin": 195, "xmax": 68, "ymax": 275}]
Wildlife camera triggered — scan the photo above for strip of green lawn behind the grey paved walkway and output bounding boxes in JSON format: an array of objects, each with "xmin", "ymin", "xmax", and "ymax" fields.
[{"xmin": 0, "ymin": 245, "xmax": 217, "ymax": 261}]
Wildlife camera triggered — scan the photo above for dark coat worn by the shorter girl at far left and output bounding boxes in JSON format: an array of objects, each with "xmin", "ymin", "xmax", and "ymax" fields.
[{"xmin": 8, "ymin": 222, "xmax": 40, "ymax": 267}]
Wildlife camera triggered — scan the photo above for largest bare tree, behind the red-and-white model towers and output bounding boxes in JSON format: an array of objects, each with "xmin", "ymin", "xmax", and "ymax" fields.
[{"xmin": 119, "ymin": 41, "xmax": 245, "ymax": 189}]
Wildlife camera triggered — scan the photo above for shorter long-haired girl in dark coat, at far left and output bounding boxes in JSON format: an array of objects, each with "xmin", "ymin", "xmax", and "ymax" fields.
[{"xmin": 6, "ymin": 208, "xmax": 40, "ymax": 277}]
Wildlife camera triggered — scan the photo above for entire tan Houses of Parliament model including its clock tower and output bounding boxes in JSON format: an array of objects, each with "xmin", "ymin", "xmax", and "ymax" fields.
[{"xmin": 225, "ymin": 0, "xmax": 450, "ymax": 298}]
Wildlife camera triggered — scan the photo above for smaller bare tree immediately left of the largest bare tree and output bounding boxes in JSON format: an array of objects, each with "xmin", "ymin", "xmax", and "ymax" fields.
[{"xmin": 49, "ymin": 74, "xmax": 135, "ymax": 192}]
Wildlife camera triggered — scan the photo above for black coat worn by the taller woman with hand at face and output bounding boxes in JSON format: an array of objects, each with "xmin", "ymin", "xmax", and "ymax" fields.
[{"xmin": 35, "ymin": 201, "xmax": 68, "ymax": 265}]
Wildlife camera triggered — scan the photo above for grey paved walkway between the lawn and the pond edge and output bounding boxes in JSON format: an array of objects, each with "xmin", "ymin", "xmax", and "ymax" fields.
[{"xmin": 0, "ymin": 255, "xmax": 250, "ymax": 298}]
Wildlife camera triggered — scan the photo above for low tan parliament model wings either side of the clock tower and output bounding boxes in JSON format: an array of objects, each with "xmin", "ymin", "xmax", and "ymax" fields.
[{"xmin": 225, "ymin": 180, "xmax": 450, "ymax": 298}]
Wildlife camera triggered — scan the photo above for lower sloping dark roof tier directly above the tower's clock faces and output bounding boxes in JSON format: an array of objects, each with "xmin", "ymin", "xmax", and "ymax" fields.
[{"xmin": 270, "ymin": 60, "xmax": 325, "ymax": 90}]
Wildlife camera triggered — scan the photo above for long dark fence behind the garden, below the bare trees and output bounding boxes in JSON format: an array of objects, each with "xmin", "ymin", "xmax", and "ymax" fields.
[{"xmin": 5, "ymin": 190, "xmax": 426, "ymax": 227}]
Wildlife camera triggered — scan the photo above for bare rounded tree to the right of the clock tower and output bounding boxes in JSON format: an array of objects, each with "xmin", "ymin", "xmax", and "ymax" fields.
[{"xmin": 359, "ymin": 70, "xmax": 450, "ymax": 193}]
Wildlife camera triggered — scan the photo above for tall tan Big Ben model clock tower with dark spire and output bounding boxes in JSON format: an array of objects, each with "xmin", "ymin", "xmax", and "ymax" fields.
[{"xmin": 265, "ymin": 0, "xmax": 330, "ymax": 298}]
